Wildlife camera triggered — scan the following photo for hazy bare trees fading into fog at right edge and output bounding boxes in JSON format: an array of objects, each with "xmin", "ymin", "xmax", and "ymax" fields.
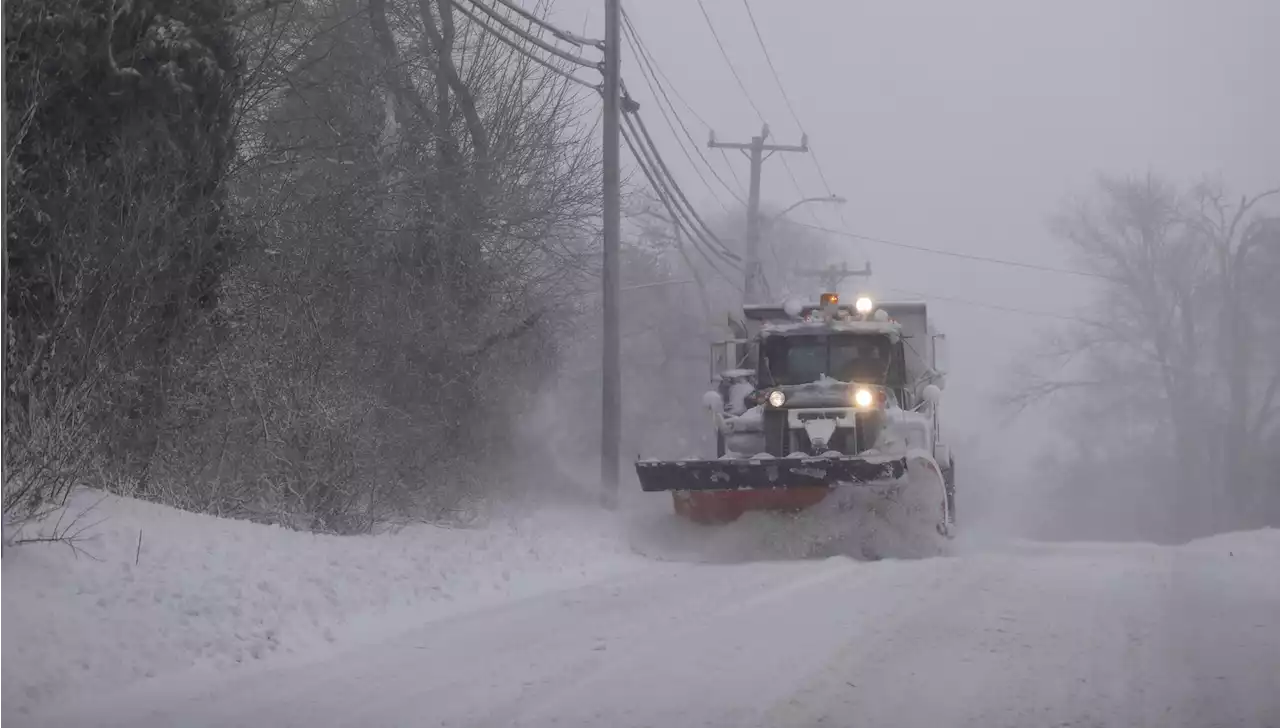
[{"xmin": 1009, "ymin": 174, "xmax": 1280, "ymax": 528}]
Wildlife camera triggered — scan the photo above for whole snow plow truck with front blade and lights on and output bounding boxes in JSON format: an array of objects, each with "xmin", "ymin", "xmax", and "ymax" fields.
[{"xmin": 636, "ymin": 293, "xmax": 955, "ymax": 535}]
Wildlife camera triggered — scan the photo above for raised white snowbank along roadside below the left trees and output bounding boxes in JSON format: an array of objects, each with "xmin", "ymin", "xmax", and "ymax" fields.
[{"xmin": 0, "ymin": 491, "xmax": 639, "ymax": 713}]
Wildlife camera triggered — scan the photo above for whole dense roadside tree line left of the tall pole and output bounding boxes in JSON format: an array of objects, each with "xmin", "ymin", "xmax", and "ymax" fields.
[{"xmin": 3, "ymin": 0, "xmax": 599, "ymax": 532}]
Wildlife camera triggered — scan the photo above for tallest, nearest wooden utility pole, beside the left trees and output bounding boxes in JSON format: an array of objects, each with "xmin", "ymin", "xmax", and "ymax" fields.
[{"xmin": 600, "ymin": 0, "xmax": 622, "ymax": 508}]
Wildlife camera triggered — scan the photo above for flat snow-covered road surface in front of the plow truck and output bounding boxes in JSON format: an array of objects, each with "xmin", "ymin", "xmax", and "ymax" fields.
[{"xmin": 22, "ymin": 531, "xmax": 1280, "ymax": 728}]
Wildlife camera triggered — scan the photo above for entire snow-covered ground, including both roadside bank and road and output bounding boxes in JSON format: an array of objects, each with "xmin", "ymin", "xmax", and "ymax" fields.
[{"xmin": 0, "ymin": 486, "xmax": 1280, "ymax": 728}]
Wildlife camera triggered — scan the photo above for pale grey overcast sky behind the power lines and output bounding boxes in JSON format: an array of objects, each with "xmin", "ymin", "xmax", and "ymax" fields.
[{"xmin": 542, "ymin": 0, "xmax": 1280, "ymax": 498}]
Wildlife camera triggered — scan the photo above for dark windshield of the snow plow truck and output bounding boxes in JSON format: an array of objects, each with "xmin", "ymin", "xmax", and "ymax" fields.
[{"xmin": 760, "ymin": 334, "xmax": 893, "ymax": 385}]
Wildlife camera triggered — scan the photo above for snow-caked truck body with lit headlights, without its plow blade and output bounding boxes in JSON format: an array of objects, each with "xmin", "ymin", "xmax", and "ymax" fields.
[{"xmin": 712, "ymin": 293, "xmax": 951, "ymax": 491}]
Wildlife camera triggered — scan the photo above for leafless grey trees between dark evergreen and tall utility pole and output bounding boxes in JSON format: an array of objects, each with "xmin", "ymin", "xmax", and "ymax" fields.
[{"xmin": 141, "ymin": 0, "xmax": 598, "ymax": 532}]
